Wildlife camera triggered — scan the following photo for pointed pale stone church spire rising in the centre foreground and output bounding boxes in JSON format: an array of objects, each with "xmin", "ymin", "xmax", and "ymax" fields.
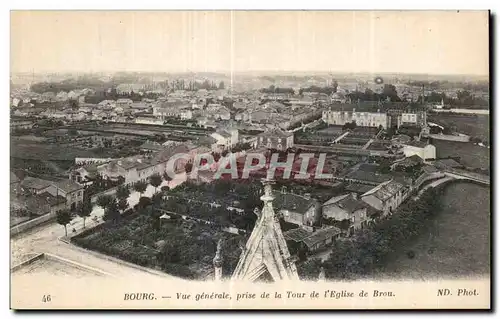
[{"xmin": 232, "ymin": 180, "xmax": 299, "ymax": 282}]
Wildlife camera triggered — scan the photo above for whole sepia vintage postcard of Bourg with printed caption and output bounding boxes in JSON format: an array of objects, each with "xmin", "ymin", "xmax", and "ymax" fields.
[{"xmin": 10, "ymin": 10, "xmax": 492, "ymax": 310}]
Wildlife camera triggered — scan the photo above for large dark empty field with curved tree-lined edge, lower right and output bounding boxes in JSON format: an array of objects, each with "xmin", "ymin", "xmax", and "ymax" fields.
[{"xmin": 375, "ymin": 183, "xmax": 491, "ymax": 279}]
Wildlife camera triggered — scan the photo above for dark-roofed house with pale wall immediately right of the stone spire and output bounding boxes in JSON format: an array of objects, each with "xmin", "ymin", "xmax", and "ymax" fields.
[{"xmin": 273, "ymin": 192, "xmax": 321, "ymax": 226}]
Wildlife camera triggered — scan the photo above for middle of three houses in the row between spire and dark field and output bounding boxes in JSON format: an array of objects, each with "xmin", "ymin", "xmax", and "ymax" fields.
[{"xmin": 322, "ymin": 193, "xmax": 370, "ymax": 235}]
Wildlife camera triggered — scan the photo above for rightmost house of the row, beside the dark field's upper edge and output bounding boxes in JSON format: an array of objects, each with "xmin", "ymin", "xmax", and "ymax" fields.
[{"xmin": 361, "ymin": 180, "xmax": 409, "ymax": 216}]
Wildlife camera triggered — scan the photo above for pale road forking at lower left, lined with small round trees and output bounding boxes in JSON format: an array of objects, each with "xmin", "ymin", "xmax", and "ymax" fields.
[{"xmin": 10, "ymin": 176, "xmax": 185, "ymax": 277}]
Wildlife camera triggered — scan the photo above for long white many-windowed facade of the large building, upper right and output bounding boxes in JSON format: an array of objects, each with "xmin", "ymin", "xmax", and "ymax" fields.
[{"xmin": 322, "ymin": 110, "xmax": 390, "ymax": 129}]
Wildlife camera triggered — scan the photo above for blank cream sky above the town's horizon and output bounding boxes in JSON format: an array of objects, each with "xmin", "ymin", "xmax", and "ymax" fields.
[{"xmin": 11, "ymin": 11, "xmax": 489, "ymax": 76}]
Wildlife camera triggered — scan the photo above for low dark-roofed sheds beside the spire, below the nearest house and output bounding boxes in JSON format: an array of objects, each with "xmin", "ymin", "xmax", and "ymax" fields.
[{"xmin": 283, "ymin": 226, "xmax": 342, "ymax": 252}]
